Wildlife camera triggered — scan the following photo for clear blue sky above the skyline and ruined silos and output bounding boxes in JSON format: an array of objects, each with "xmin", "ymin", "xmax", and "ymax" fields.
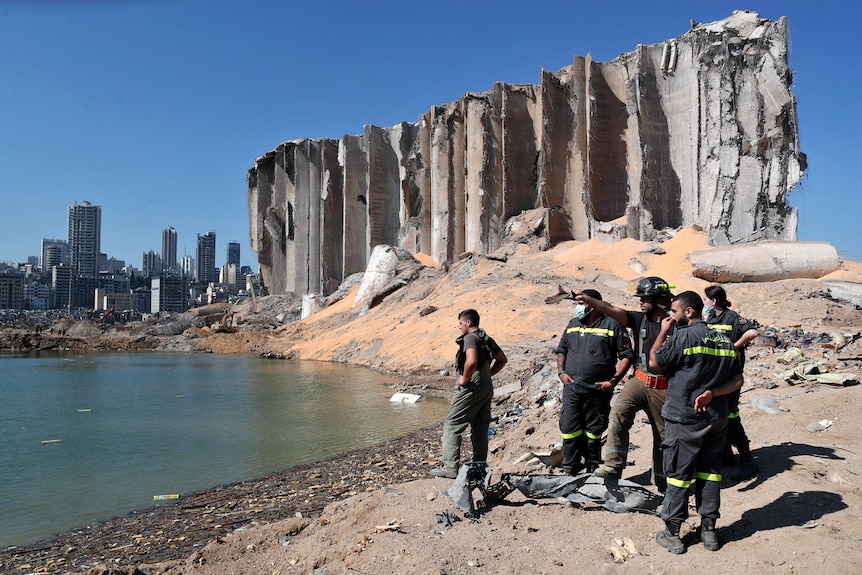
[{"xmin": 0, "ymin": 0, "xmax": 862, "ymax": 269}]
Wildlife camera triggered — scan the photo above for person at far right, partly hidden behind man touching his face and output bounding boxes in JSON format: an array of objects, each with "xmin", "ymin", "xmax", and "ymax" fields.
[{"xmin": 703, "ymin": 285, "xmax": 760, "ymax": 481}]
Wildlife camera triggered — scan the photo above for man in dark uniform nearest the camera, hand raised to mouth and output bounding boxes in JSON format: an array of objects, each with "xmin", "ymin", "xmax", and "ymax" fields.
[{"xmin": 649, "ymin": 291, "xmax": 742, "ymax": 554}]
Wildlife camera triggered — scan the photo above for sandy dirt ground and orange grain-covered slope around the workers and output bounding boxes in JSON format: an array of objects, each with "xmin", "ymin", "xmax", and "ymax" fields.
[{"xmin": 0, "ymin": 229, "xmax": 862, "ymax": 575}]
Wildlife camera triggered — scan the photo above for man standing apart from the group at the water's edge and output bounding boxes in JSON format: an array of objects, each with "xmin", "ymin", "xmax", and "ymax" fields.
[{"xmin": 431, "ymin": 309, "xmax": 508, "ymax": 479}]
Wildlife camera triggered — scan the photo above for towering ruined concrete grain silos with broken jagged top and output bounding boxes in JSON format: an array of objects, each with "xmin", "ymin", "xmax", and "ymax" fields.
[{"xmin": 248, "ymin": 12, "xmax": 805, "ymax": 296}]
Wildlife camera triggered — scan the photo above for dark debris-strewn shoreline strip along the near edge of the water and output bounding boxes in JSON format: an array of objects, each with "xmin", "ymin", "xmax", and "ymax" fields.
[{"xmin": 0, "ymin": 424, "xmax": 442, "ymax": 573}]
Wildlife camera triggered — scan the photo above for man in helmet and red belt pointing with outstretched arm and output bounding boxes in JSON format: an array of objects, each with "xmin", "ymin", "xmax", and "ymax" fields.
[{"xmin": 575, "ymin": 276, "xmax": 673, "ymax": 493}]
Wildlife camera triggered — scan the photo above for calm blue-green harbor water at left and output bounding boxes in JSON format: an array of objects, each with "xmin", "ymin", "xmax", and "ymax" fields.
[{"xmin": 0, "ymin": 353, "xmax": 448, "ymax": 548}]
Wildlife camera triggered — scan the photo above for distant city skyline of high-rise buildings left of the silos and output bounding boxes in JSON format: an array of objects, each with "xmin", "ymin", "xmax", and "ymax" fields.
[{"xmin": 0, "ymin": 201, "xmax": 251, "ymax": 317}]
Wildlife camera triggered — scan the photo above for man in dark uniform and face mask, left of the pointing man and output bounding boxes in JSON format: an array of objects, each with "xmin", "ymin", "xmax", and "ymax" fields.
[{"xmin": 554, "ymin": 289, "xmax": 634, "ymax": 475}]
